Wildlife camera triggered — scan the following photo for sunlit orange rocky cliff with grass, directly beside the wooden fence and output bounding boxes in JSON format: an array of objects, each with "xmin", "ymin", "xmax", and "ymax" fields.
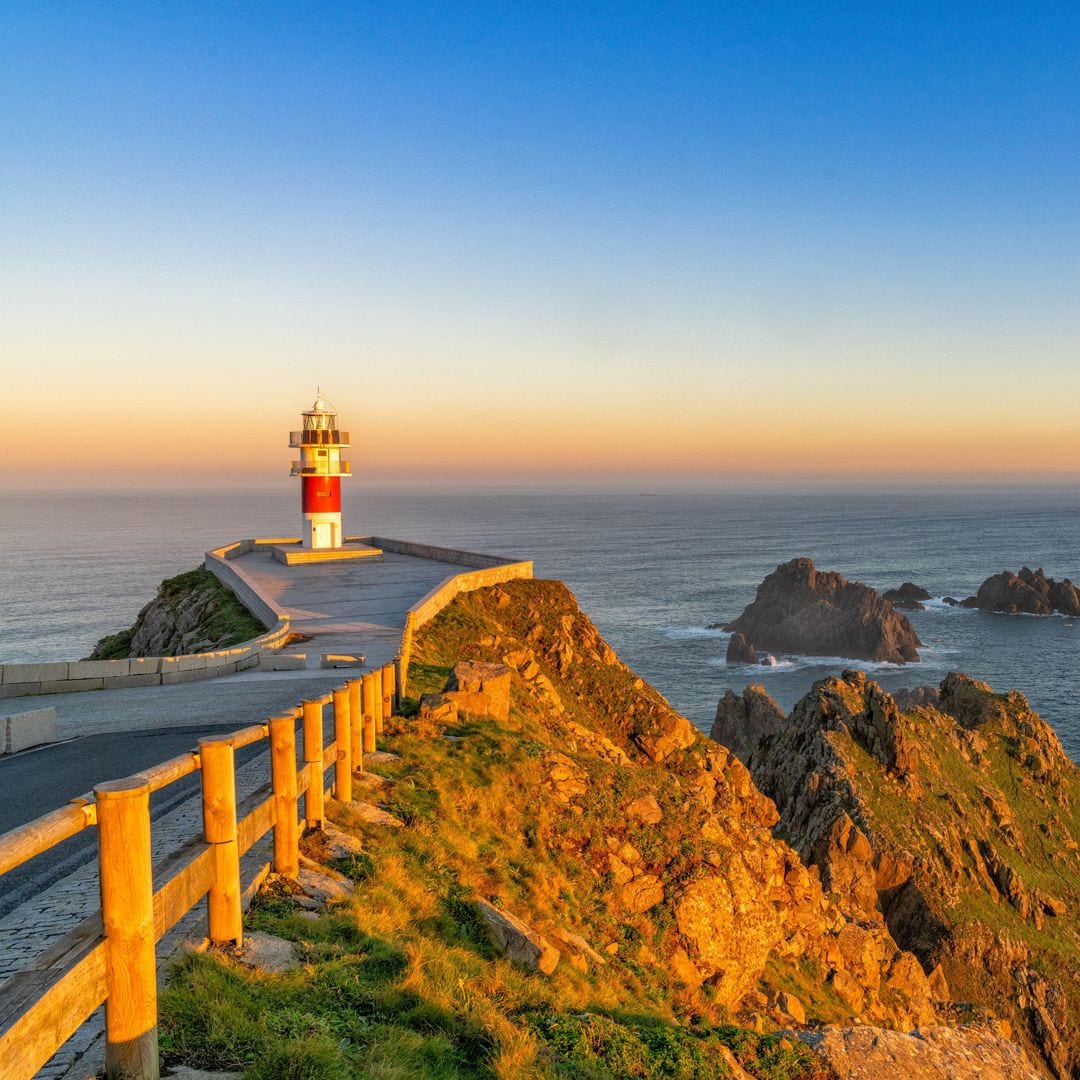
[{"xmin": 156, "ymin": 581, "xmax": 1036, "ymax": 1080}]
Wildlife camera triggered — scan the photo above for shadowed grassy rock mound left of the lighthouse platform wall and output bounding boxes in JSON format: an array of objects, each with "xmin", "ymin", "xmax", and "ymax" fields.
[{"xmin": 86, "ymin": 568, "xmax": 267, "ymax": 660}]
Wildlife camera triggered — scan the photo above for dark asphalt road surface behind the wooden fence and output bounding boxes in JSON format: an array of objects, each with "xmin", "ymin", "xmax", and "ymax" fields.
[{"xmin": 0, "ymin": 724, "xmax": 266, "ymax": 917}]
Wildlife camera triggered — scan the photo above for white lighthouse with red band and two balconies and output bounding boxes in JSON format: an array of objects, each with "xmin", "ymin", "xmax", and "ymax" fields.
[{"xmin": 288, "ymin": 395, "xmax": 352, "ymax": 551}]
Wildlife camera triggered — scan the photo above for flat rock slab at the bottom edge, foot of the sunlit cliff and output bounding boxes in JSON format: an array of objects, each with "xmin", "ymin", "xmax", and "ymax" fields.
[{"xmin": 792, "ymin": 1025, "xmax": 1041, "ymax": 1080}]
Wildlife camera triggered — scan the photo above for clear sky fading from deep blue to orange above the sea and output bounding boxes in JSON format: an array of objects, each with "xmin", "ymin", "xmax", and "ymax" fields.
[{"xmin": 0, "ymin": 0, "xmax": 1080, "ymax": 488}]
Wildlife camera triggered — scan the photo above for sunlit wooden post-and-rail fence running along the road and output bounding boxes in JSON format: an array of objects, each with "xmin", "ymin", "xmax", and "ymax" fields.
[{"xmin": 0, "ymin": 664, "xmax": 400, "ymax": 1080}]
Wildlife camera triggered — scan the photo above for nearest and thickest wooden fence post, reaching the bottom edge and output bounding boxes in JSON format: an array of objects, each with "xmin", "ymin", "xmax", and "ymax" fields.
[{"xmin": 94, "ymin": 777, "xmax": 160, "ymax": 1080}]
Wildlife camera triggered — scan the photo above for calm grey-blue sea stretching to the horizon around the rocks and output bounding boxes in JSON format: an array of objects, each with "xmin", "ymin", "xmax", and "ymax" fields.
[{"xmin": 0, "ymin": 484, "xmax": 1080, "ymax": 760}]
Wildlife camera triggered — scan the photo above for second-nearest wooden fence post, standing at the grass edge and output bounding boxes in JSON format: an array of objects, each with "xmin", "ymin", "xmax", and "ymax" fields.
[{"xmin": 199, "ymin": 737, "xmax": 244, "ymax": 945}]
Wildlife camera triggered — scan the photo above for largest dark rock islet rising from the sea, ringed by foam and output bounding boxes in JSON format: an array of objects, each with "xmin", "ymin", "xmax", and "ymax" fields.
[{"xmin": 725, "ymin": 558, "xmax": 922, "ymax": 663}]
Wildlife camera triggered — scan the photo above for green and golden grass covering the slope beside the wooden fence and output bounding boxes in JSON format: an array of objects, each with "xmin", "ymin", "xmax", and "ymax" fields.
[{"xmin": 161, "ymin": 583, "xmax": 827, "ymax": 1080}]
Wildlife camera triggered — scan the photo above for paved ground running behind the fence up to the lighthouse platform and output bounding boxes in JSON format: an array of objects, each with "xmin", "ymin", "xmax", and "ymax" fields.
[{"xmin": 0, "ymin": 551, "xmax": 463, "ymax": 1080}]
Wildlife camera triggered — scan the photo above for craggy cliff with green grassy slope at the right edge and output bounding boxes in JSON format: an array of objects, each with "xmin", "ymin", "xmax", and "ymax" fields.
[{"xmin": 750, "ymin": 672, "xmax": 1080, "ymax": 1078}]
